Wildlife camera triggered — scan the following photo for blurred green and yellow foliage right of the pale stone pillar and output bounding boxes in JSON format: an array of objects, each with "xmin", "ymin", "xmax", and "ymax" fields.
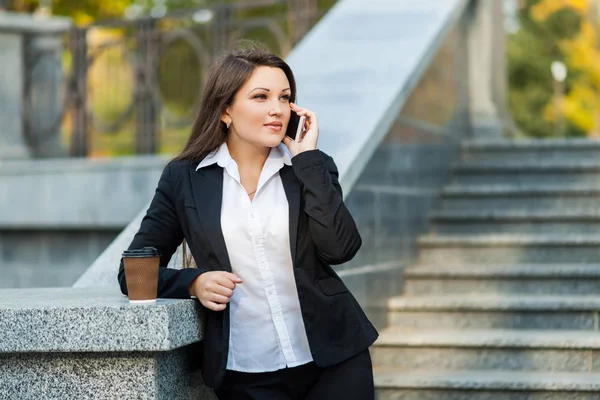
[{"xmin": 507, "ymin": 0, "xmax": 600, "ymax": 137}]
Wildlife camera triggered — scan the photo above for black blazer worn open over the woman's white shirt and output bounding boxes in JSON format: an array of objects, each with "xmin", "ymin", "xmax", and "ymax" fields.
[{"xmin": 118, "ymin": 150, "xmax": 378, "ymax": 388}]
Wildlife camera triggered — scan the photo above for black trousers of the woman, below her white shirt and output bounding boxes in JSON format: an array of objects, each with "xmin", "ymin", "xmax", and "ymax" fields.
[{"xmin": 216, "ymin": 350, "xmax": 375, "ymax": 400}]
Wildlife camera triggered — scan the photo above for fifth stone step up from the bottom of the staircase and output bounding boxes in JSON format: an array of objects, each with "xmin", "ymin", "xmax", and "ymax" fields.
[{"xmin": 418, "ymin": 234, "xmax": 600, "ymax": 264}]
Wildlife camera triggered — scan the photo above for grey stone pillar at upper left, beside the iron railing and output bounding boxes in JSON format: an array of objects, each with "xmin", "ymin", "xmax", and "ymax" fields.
[{"xmin": 0, "ymin": 12, "xmax": 71, "ymax": 160}]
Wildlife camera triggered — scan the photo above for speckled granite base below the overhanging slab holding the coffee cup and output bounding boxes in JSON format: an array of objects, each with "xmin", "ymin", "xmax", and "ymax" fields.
[{"xmin": 0, "ymin": 346, "xmax": 216, "ymax": 400}]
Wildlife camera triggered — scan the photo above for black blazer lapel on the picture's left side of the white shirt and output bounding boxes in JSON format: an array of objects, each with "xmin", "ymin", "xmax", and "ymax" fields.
[{"xmin": 190, "ymin": 165, "xmax": 231, "ymax": 272}]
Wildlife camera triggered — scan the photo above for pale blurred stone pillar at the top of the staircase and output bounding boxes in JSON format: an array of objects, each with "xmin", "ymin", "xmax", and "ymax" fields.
[{"xmin": 468, "ymin": 0, "xmax": 508, "ymax": 139}]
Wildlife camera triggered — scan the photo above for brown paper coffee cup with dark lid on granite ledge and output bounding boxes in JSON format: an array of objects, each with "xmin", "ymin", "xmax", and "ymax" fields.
[{"xmin": 123, "ymin": 247, "xmax": 160, "ymax": 304}]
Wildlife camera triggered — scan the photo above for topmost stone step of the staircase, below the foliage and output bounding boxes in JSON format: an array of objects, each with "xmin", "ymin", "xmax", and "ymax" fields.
[{"xmin": 461, "ymin": 139, "xmax": 600, "ymax": 162}]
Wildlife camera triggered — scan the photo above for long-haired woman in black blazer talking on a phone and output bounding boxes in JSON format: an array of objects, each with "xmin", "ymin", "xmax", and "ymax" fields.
[{"xmin": 118, "ymin": 45, "xmax": 377, "ymax": 400}]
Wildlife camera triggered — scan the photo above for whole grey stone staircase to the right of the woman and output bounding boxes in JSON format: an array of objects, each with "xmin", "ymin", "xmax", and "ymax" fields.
[{"xmin": 371, "ymin": 140, "xmax": 600, "ymax": 400}]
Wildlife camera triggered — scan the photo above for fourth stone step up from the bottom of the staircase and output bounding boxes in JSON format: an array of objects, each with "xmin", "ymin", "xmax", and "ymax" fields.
[{"xmin": 404, "ymin": 264, "xmax": 600, "ymax": 296}]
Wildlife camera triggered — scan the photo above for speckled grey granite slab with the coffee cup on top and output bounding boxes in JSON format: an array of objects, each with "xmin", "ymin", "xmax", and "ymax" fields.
[{"xmin": 0, "ymin": 288, "xmax": 203, "ymax": 353}]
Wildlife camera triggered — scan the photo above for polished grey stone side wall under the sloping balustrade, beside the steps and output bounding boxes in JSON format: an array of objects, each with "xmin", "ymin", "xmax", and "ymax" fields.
[{"xmin": 339, "ymin": 15, "xmax": 470, "ymax": 327}]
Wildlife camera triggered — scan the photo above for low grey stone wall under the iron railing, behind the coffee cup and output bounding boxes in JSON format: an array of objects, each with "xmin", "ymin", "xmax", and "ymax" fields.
[{"xmin": 0, "ymin": 157, "xmax": 167, "ymax": 288}]
